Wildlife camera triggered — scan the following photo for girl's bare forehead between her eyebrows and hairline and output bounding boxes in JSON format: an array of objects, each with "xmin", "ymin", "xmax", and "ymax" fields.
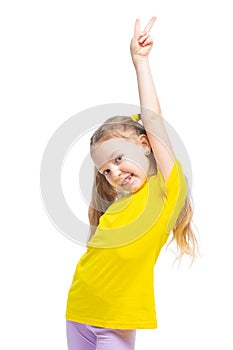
[{"xmin": 92, "ymin": 138, "xmax": 139, "ymax": 169}]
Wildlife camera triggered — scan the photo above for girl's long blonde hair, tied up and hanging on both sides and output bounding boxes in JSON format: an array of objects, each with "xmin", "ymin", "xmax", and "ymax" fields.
[{"xmin": 88, "ymin": 116, "xmax": 198, "ymax": 260}]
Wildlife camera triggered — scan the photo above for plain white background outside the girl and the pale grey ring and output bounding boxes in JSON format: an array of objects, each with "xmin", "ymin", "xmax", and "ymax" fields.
[{"xmin": 0, "ymin": 0, "xmax": 233, "ymax": 350}]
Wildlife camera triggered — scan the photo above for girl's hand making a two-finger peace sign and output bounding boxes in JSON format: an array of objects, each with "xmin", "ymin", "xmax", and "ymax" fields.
[{"xmin": 130, "ymin": 16, "xmax": 156, "ymax": 63}]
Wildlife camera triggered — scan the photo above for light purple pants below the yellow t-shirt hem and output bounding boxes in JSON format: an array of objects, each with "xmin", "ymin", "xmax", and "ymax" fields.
[{"xmin": 66, "ymin": 320, "xmax": 136, "ymax": 350}]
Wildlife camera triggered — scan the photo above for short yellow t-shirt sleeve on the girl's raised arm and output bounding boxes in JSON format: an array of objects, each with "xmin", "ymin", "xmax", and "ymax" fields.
[{"xmin": 158, "ymin": 157, "xmax": 187, "ymax": 233}]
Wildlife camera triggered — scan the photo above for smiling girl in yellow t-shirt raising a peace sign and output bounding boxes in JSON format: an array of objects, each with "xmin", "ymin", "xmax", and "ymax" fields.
[{"xmin": 66, "ymin": 17, "xmax": 197, "ymax": 350}]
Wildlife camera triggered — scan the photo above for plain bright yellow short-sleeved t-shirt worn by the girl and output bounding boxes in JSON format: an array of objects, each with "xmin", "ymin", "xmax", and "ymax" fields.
[{"xmin": 66, "ymin": 158, "xmax": 187, "ymax": 329}]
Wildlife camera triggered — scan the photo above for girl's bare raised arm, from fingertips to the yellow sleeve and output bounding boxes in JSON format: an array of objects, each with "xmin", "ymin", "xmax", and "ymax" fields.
[{"xmin": 130, "ymin": 17, "xmax": 174, "ymax": 181}]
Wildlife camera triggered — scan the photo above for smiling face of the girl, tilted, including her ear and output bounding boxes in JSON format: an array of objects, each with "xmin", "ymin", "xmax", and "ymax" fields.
[{"xmin": 92, "ymin": 135, "xmax": 153, "ymax": 192}]
